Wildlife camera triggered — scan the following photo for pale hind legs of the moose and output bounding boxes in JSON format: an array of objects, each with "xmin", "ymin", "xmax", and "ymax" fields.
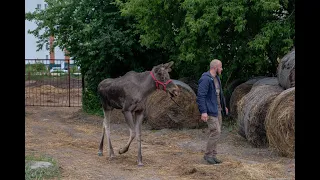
[{"xmin": 98, "ymin": 110, "xmax": 114, "ymax": 159}]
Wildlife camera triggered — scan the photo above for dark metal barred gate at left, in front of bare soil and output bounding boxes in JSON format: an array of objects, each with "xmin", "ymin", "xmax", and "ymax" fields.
[{"xmin": 25, "ymin": 59, "xmax": 83, "ymax": 107}]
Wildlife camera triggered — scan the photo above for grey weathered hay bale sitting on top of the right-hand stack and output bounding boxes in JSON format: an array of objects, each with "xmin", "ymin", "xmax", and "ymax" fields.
[{"xmin": 277, "ymin": 48, "xmax": 295, "ymax": 89}]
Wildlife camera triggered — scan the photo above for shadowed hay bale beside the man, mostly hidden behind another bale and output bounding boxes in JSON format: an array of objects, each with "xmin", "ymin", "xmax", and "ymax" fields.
[{"xmin": 229, "ymin": 76, "xmax": 264, "ymax": 119}]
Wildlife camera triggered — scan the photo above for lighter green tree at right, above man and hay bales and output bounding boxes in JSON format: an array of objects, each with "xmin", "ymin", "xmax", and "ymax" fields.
[{"xmin": 116, "ymin": 0, "xmax": 295, "ymax": 84}]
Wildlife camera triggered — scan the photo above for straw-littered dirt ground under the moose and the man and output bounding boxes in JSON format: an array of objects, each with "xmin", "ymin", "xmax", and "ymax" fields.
[{"xmin": 25, "ymin": 106, "xmax": 295, "ymax": 180}]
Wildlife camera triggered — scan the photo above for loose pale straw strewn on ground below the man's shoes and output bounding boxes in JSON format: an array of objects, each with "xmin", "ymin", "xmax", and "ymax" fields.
[{"xmin": 175, "ymin": 157, "xmax": 287, "ymax": 180}]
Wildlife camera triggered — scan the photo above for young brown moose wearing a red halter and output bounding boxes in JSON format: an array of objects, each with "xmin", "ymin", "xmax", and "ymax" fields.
[{"xmin": 98, "ymin": 62, "xmax": 180, "ymax": 166}]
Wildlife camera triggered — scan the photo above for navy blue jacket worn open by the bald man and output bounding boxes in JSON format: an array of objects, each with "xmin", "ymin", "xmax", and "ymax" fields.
[{"xmin": 197, "ymin": 71, "xmax": 226, "ymax": 117}]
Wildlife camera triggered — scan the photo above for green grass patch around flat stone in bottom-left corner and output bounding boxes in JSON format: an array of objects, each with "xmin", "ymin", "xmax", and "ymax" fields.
[{"xmin": 25, "ymin": 154, "xmax": 60, "ymax": 180}]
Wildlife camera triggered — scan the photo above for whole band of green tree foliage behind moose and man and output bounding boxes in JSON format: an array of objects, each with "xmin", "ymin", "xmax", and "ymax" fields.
[{"xmin": 26, "ymin": 0, "xmax": 295, "ymax": 110}]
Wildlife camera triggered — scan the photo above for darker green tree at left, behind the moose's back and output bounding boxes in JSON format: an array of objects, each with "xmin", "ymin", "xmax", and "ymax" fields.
[{"xmin": 26, "ymin": 0, "xmax": 168, "ymax": 112}]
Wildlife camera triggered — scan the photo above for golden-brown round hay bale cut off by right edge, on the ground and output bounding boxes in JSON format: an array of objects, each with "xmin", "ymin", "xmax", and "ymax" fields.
[{"xmin": 265, "ymin": 87, "xmax": 295, "ymax": 158}]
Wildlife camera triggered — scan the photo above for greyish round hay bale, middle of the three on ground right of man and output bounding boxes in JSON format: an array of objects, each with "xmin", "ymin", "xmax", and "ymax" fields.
[{"xmin": 238, "ymin": 85, "xmax": 283, "ymax": 147}]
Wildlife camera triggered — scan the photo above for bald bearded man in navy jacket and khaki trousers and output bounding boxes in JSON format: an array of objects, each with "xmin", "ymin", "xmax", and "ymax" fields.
[{"xmin": 197, "ymin": 59, "xmax": 228, "ymax": 164}]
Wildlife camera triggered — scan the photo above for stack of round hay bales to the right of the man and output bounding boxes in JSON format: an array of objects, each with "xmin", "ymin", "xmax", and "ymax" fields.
[{"xmin": 230, "ymin": 48, "xmax": 295, "ymax": 153}]
